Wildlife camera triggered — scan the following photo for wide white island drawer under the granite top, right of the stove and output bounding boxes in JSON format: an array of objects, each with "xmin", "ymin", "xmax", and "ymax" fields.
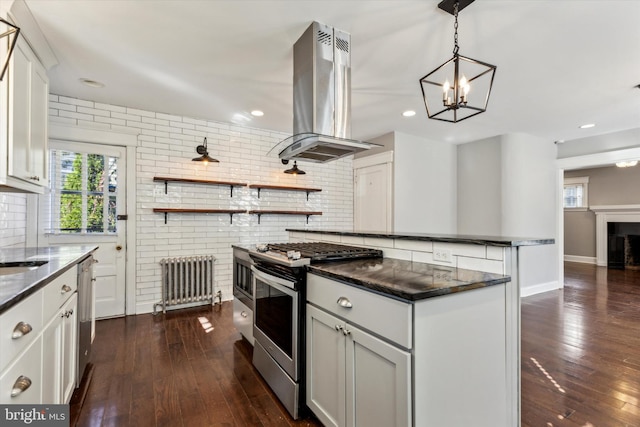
[{"xmin": 307, "ymin": 273, "xmax": 413, "ymax": 349}]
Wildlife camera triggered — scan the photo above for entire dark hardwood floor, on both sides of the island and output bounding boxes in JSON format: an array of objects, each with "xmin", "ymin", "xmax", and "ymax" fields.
[{"xmin": 72, "ymin": 263, "xmax": 640, "ymax": 427}]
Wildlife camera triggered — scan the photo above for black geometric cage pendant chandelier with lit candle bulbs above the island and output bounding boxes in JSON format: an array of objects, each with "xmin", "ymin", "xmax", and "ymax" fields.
[{"xmin": 420, "ymin": 0, "xmax": 497, "ymax": 123}]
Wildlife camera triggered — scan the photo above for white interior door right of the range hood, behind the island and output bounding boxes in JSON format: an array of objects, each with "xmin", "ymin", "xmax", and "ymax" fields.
[{"xmin": 354, "ymin": 163, "xmax": 393, "ymax": 232}]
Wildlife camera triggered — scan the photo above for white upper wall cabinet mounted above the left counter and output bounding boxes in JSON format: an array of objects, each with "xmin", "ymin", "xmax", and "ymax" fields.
[{"xmin": 0, "ymin": 37, "xmax": 49, "ymax": 194}]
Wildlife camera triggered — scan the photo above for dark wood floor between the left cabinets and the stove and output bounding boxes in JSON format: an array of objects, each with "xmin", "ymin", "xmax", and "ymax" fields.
[{"xmin": 72, "ymin": 302, "xmax": 321, "ymax": 427}]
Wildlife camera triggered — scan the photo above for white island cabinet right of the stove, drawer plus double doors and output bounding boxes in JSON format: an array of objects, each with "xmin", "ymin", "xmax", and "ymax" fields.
[{"xmin": 306, "ymin": 274, "xmax": 412, "ymax": 427}]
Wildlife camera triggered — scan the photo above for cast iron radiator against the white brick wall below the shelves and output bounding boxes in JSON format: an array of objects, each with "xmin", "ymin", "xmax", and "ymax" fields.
[{"xmin": 153, "ymin": 255, "xmax": 222, "ymax": 314}]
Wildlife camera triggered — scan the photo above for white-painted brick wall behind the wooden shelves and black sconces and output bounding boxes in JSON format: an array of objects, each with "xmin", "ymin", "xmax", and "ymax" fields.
[{"xmin": 49, "ymin": 95, "xmax": 353, "ymax": 313}]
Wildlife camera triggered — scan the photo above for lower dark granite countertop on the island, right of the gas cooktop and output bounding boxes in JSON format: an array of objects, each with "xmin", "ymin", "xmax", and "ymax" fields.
[{"xmin": 308, "ymin": 258, "xmax": 511, "ymax": 302}]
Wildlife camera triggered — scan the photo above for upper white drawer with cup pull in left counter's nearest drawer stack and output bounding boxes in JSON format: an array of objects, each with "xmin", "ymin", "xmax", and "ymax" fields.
[{"xmin": 0, "ymin": 289, "xmax": 43, "ymax": 372}]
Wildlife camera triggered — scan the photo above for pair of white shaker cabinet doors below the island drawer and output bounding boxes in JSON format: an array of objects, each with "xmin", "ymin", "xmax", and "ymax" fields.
[{"xmin": 306, "ymin": 304, "xmax": 411, "ymax": 427}]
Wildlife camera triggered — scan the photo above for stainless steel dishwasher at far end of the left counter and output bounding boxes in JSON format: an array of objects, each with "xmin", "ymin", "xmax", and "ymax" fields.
[{"xmin": 76, "ymin": 255, "xmax": 94, "ymax": 385}]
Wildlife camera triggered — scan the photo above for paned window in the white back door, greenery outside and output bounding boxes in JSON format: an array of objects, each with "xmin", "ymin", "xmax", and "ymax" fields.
[{"xmin": 49, "ymin": 149, "xmax": 118, "ymax": 234}]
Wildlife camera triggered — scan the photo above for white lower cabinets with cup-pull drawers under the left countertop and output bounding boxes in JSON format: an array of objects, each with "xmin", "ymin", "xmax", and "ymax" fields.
[{"xmin": 0, "ymin": 266, "xmax": 78, "ymax": 404}]
